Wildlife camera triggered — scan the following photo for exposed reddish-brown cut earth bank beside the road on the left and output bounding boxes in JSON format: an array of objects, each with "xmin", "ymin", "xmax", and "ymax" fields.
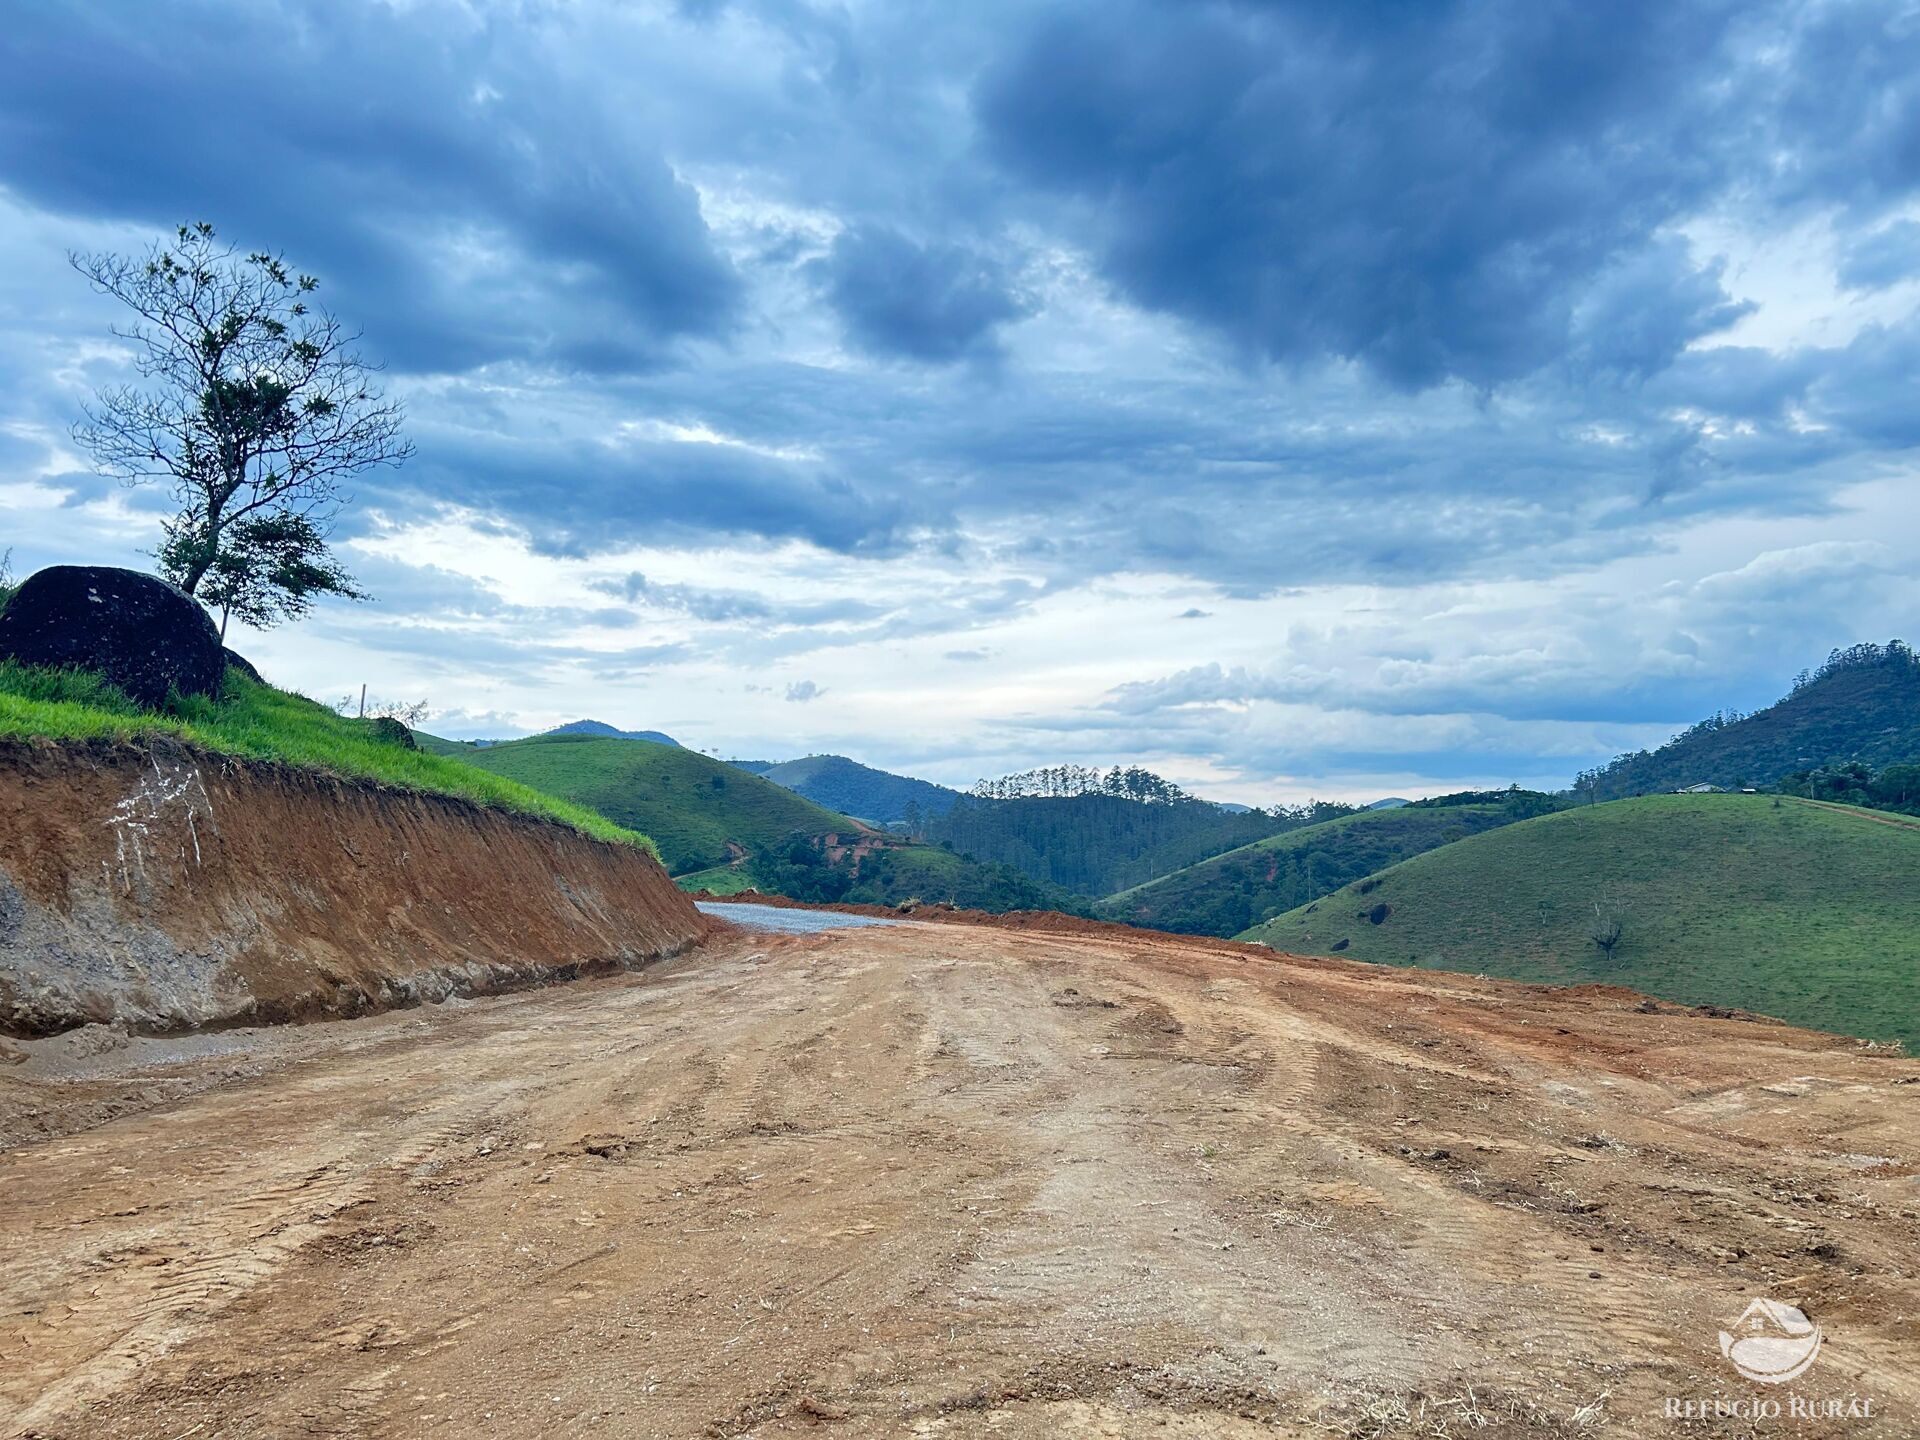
[{"xmin": 0, "ymin": 739, "xmax": 710, "ymax": 1035}]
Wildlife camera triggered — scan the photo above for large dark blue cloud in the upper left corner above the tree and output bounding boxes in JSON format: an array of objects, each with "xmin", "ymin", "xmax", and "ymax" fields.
[{"xmin": 0, "ymin": 0, "xmax": 737, "ymax": 371}]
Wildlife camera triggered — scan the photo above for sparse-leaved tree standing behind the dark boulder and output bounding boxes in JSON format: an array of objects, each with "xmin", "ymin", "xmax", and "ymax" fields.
[{"xmin": 67, "ymin": 225, "xmax": 413, "ymax": 622}]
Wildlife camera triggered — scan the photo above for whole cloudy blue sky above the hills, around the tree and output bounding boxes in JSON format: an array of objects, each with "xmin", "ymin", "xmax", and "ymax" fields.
[{"xmin": 0, "ymin": 0, "xmax": 1920, "ymax": 804}]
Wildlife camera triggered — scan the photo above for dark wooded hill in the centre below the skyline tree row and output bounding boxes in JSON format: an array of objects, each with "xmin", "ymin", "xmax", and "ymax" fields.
[{"xmin": 916, "ymin": 795, "xmax": 1286, "ymax": 895}]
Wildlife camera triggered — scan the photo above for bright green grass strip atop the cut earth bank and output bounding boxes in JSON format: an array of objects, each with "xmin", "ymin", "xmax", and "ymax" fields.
[{"xmin": 0, "ymin": 660, "xmax": 659, "ymax": 854}]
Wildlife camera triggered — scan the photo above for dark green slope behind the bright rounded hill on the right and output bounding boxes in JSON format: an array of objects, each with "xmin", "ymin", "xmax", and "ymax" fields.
[{"xmin": 1096, "ymin": 801, "xmax": 1523, "ymax": 935}]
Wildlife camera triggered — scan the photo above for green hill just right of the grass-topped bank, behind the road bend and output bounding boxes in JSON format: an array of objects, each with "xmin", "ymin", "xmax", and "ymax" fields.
[{"xmin": 459, "ymin": 735, "xmax": 860, "ymax": 876}]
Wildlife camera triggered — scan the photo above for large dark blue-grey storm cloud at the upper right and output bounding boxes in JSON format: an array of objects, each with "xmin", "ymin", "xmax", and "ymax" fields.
[{"xmin": 977, "ymin": 0, "xmax": 1920, "ymax": 386}]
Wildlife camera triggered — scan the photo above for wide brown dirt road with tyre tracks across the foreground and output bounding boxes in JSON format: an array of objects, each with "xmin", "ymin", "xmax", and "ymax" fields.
[{"xmin": 0, "ymin": 925, "xmax": 1920, "ymax": 1440}]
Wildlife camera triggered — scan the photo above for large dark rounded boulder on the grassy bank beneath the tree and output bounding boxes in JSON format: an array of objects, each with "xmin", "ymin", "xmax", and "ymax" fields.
[{"xmin": 0, "ymin": 564, "xmax": 227, "ymax": 708}]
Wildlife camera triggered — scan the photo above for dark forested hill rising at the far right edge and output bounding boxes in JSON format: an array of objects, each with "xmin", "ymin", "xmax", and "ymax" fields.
[{"xmin": 1578, "ymin": 641, "xmax": 1920, "ymax": 799}]
